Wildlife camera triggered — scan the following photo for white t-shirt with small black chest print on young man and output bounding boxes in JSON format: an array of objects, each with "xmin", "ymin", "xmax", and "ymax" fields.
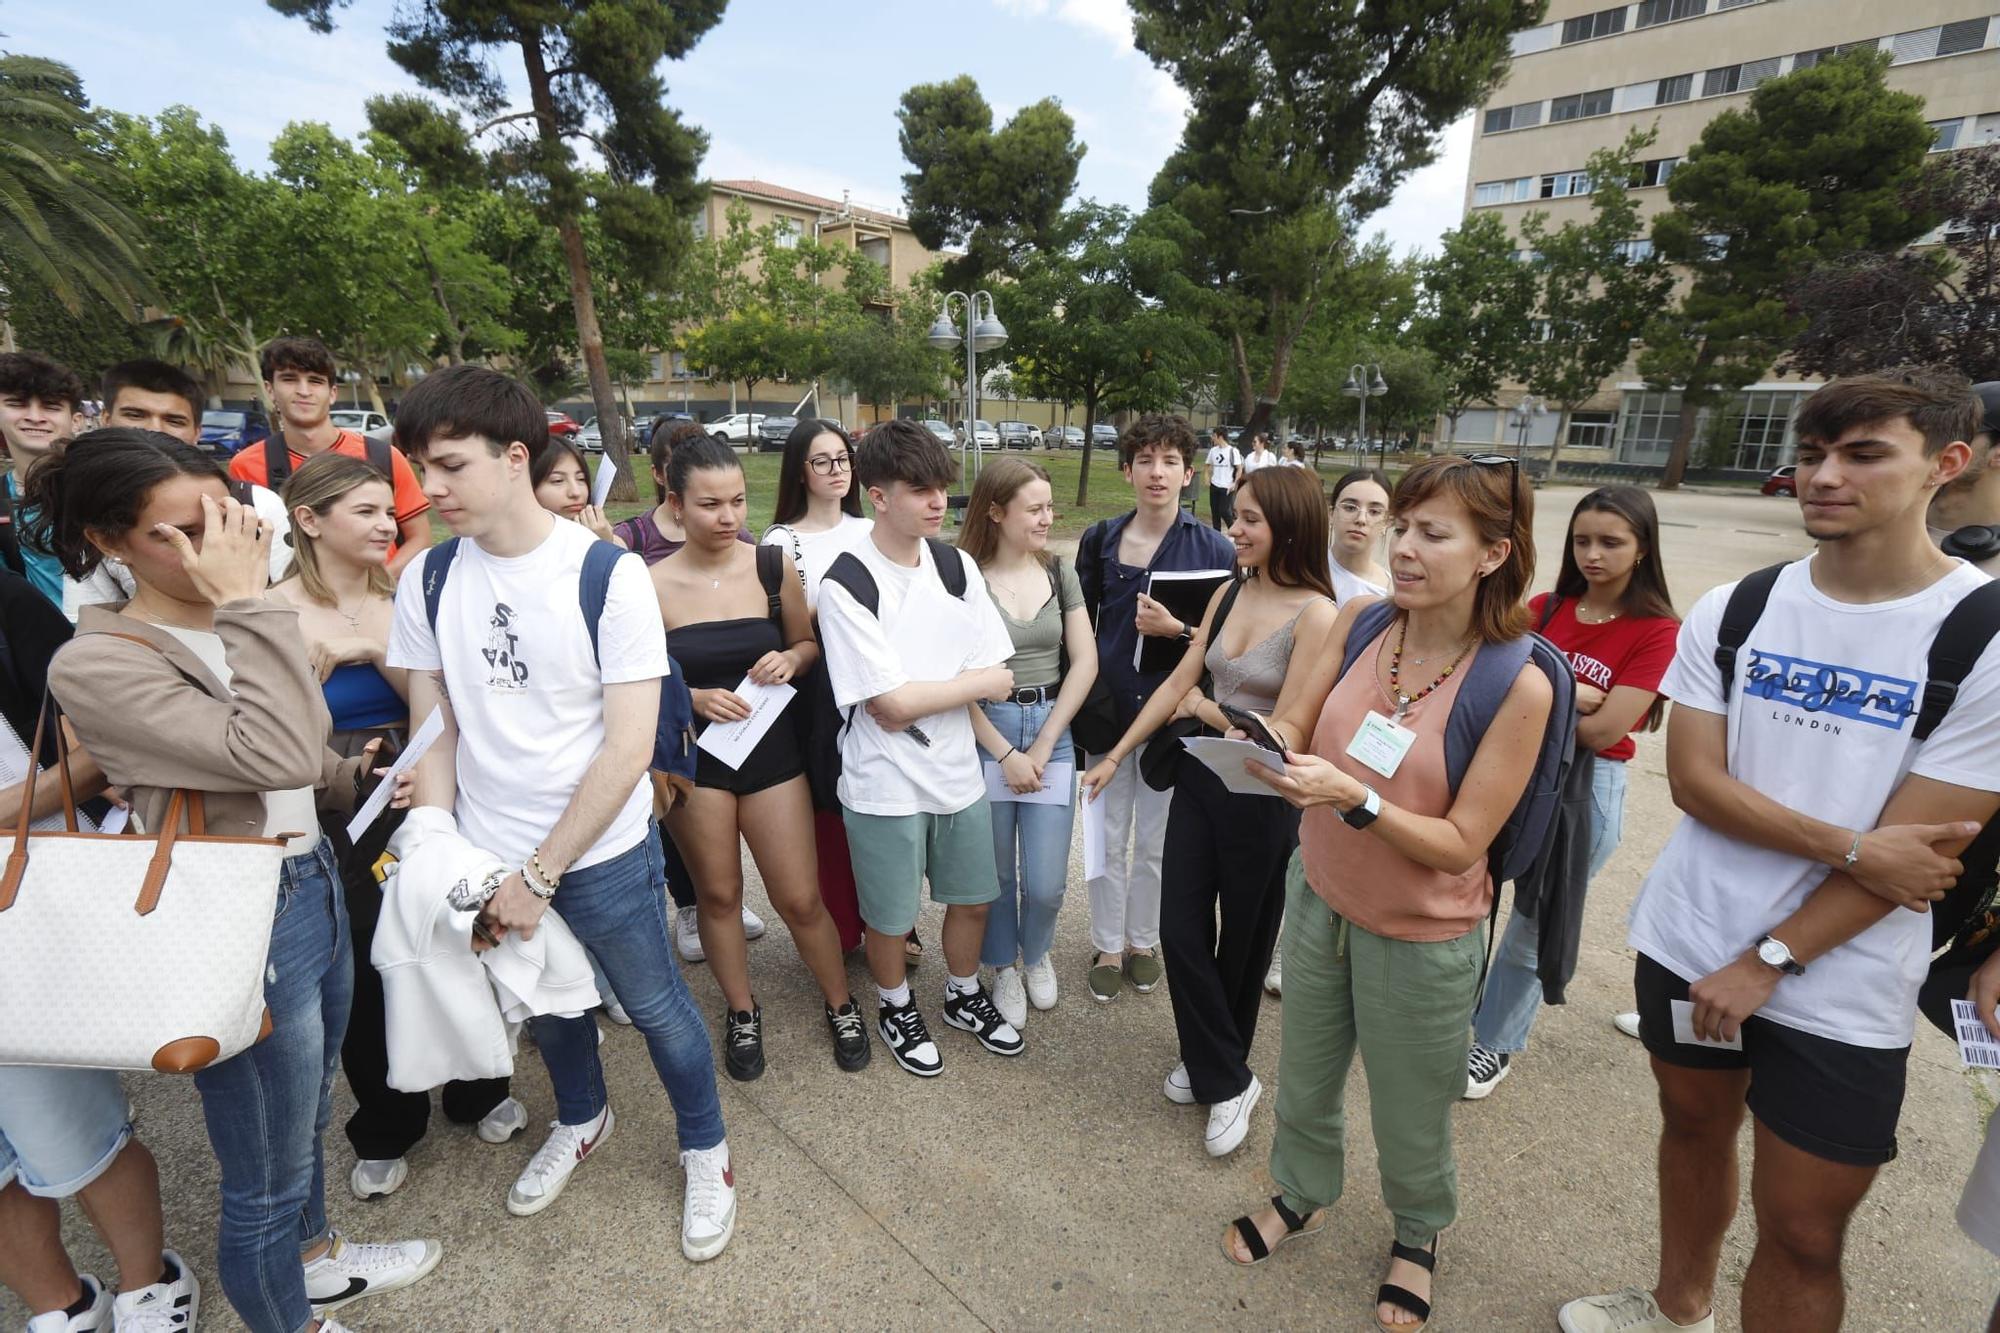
[{"xmin": 388, "ymin": 522, "xmax": 668, "ymax": 869}]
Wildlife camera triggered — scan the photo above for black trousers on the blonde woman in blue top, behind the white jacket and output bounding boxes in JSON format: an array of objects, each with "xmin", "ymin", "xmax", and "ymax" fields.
[{"xmin": 326, "ymin": 811, "xmax": 508, "ymax": 1161}]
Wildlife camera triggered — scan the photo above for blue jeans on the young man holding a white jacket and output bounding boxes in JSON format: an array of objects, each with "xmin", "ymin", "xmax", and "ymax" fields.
[{"xmin": 532, "ymin": 825, "xmax": 722, "ymax": 1149}]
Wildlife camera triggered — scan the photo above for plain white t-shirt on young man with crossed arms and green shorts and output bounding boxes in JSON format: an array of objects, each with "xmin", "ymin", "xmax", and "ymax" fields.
[{"xmin": 820, "ymin": 540, "xmax": 1014, "ymax": 815}]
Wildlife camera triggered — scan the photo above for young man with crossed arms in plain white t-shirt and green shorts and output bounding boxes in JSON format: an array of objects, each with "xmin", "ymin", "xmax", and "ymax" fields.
[{"xmin": 820, "ymin": 420, "xmax": 1022, "ymax": 1079}]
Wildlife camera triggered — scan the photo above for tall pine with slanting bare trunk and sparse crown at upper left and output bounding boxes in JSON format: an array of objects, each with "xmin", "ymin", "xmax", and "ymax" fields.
[{"xmin": 268, "ymin": 0, "xmax": 724, "ymax": 498}]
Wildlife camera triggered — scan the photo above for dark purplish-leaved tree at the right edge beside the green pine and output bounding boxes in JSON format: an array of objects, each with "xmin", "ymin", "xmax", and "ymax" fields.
[{"xmin": 1786, "ymin": 144, "xmax": 2000, "ymax": 382}]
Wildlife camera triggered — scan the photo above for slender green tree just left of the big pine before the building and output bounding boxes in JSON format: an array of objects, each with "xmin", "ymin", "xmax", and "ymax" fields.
[{"xmin": 1516, "ymin": 130, "xmax": 1674, "ymax": 476}]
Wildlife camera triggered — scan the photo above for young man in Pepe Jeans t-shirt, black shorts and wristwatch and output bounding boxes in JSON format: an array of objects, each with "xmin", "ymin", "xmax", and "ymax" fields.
[{"xmin": 1558, "ymin": 370, "xmax": 2000, "ymax": 1333}]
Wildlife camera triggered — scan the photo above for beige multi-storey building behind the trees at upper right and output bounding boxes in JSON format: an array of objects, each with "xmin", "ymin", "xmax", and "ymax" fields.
[{"xmin": 1456, "ymin": 0, "xmax": 2000, "ymax": 470}]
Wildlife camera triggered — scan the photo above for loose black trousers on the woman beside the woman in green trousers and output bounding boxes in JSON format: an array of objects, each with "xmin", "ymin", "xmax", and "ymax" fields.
[{"xmin": 1160, "ymin": 757, "xmax": 1298, "ymax": 1105}]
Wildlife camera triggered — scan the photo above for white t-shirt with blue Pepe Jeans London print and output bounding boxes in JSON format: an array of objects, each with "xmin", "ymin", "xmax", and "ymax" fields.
[{"xmin": 1630, "ymin": 556, "xmax": 2000, "ymax": 1049}]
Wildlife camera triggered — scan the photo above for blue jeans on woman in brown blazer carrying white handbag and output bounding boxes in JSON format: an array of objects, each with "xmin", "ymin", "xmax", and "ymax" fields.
[{"xmin": 194, "ymin": 841, "xmax": 354, "ymax": 1333}]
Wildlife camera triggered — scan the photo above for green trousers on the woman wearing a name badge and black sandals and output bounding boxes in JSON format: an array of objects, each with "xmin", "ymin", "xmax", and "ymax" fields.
[{"xmin": 1270, "ymin": 853, "xmax": 1486, "ymax": 1247}]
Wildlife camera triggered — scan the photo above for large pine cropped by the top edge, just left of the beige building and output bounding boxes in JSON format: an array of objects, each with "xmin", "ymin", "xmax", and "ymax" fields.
[{"xmin": 1134, "ymin": 0, "xmax": 1544, "ymax": 428}]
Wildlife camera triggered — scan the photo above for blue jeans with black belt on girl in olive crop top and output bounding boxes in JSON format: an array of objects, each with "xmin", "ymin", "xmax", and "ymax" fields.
[{"xmin": 980, "ymin": 703, "xmax": 1076, "ymax": 967}]
